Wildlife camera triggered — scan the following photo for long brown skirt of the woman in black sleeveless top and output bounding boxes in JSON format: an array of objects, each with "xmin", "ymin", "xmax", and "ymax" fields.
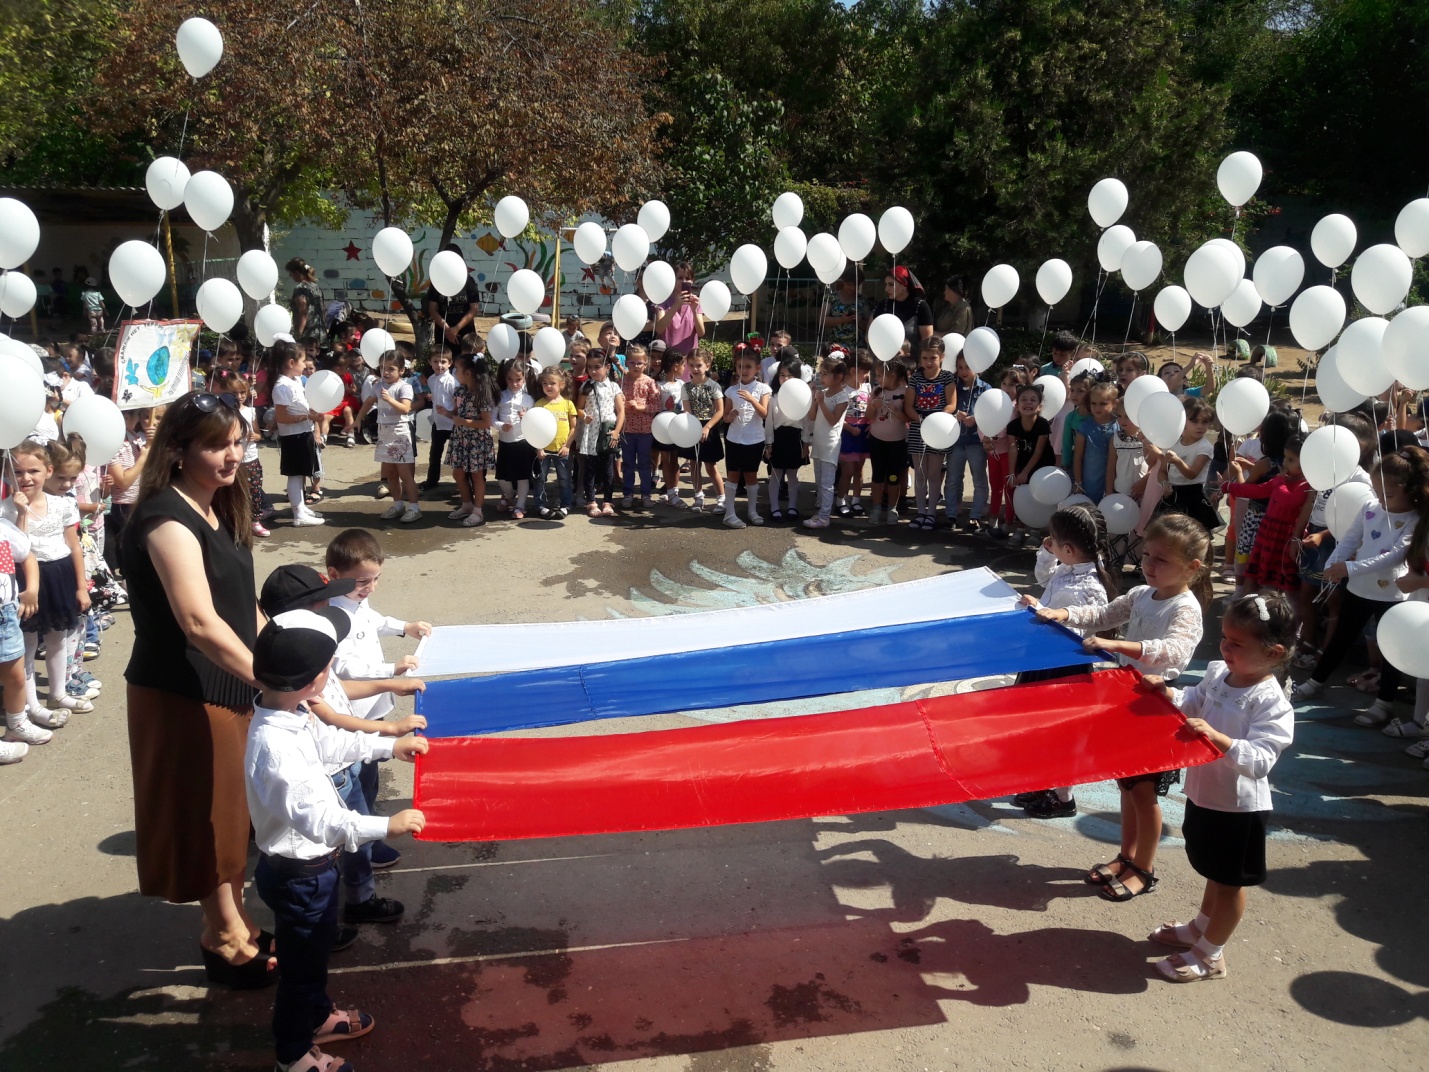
[{"xmin": 127, "ymin": 685, "xmax": 253, "ymax": 903}]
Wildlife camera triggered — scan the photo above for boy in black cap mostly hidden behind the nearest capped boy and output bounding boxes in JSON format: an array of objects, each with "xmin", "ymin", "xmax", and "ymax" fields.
[{"xmin": 259, "ymin": 565, "xmax": 427, "ymax": 952}]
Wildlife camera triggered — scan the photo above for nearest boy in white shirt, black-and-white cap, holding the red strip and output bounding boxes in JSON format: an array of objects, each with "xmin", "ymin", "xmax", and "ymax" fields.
[{"xmin": 244, "ymin": 607, "xmax": 427, "ymax": 1072}]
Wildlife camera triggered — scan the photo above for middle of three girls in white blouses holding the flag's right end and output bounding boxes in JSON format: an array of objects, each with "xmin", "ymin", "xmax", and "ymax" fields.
[{"xmin": 1037, "ymin": 513, "xmax": 1210, "ymax": 900}]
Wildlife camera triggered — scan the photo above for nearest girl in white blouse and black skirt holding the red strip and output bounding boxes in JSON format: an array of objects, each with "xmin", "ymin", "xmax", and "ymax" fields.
[{"xmin": 1146, "ymin": 592, "xmax": 1295, "ymax": 982}]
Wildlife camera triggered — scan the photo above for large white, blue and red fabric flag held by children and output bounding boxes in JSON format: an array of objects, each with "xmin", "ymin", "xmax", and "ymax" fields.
[{"xmin": 414, "ymin": 569, "xmax": 1218, "ymax": 840}]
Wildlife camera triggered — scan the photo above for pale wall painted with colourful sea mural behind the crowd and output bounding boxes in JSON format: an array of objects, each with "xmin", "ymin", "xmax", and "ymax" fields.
[{"xmin": 273, "ymin": 212, "xmax": 743, "ymax": 327}]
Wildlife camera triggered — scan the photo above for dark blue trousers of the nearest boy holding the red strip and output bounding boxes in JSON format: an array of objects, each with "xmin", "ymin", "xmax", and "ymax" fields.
[{"xmin": 253, "ymin": 853, "xmax": 337, "ymax": 1065}]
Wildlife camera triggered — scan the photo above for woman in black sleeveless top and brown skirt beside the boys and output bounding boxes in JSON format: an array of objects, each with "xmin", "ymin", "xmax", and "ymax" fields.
[{"xmin": 121, "ymin": 393, "xmax": 274, "ymax": 986}]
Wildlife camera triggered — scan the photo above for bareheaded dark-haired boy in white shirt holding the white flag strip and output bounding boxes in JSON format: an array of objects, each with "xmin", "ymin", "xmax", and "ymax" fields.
[{"xmin": 326, "ymin": 529, "xmax": 432, "ymax": 874}]
